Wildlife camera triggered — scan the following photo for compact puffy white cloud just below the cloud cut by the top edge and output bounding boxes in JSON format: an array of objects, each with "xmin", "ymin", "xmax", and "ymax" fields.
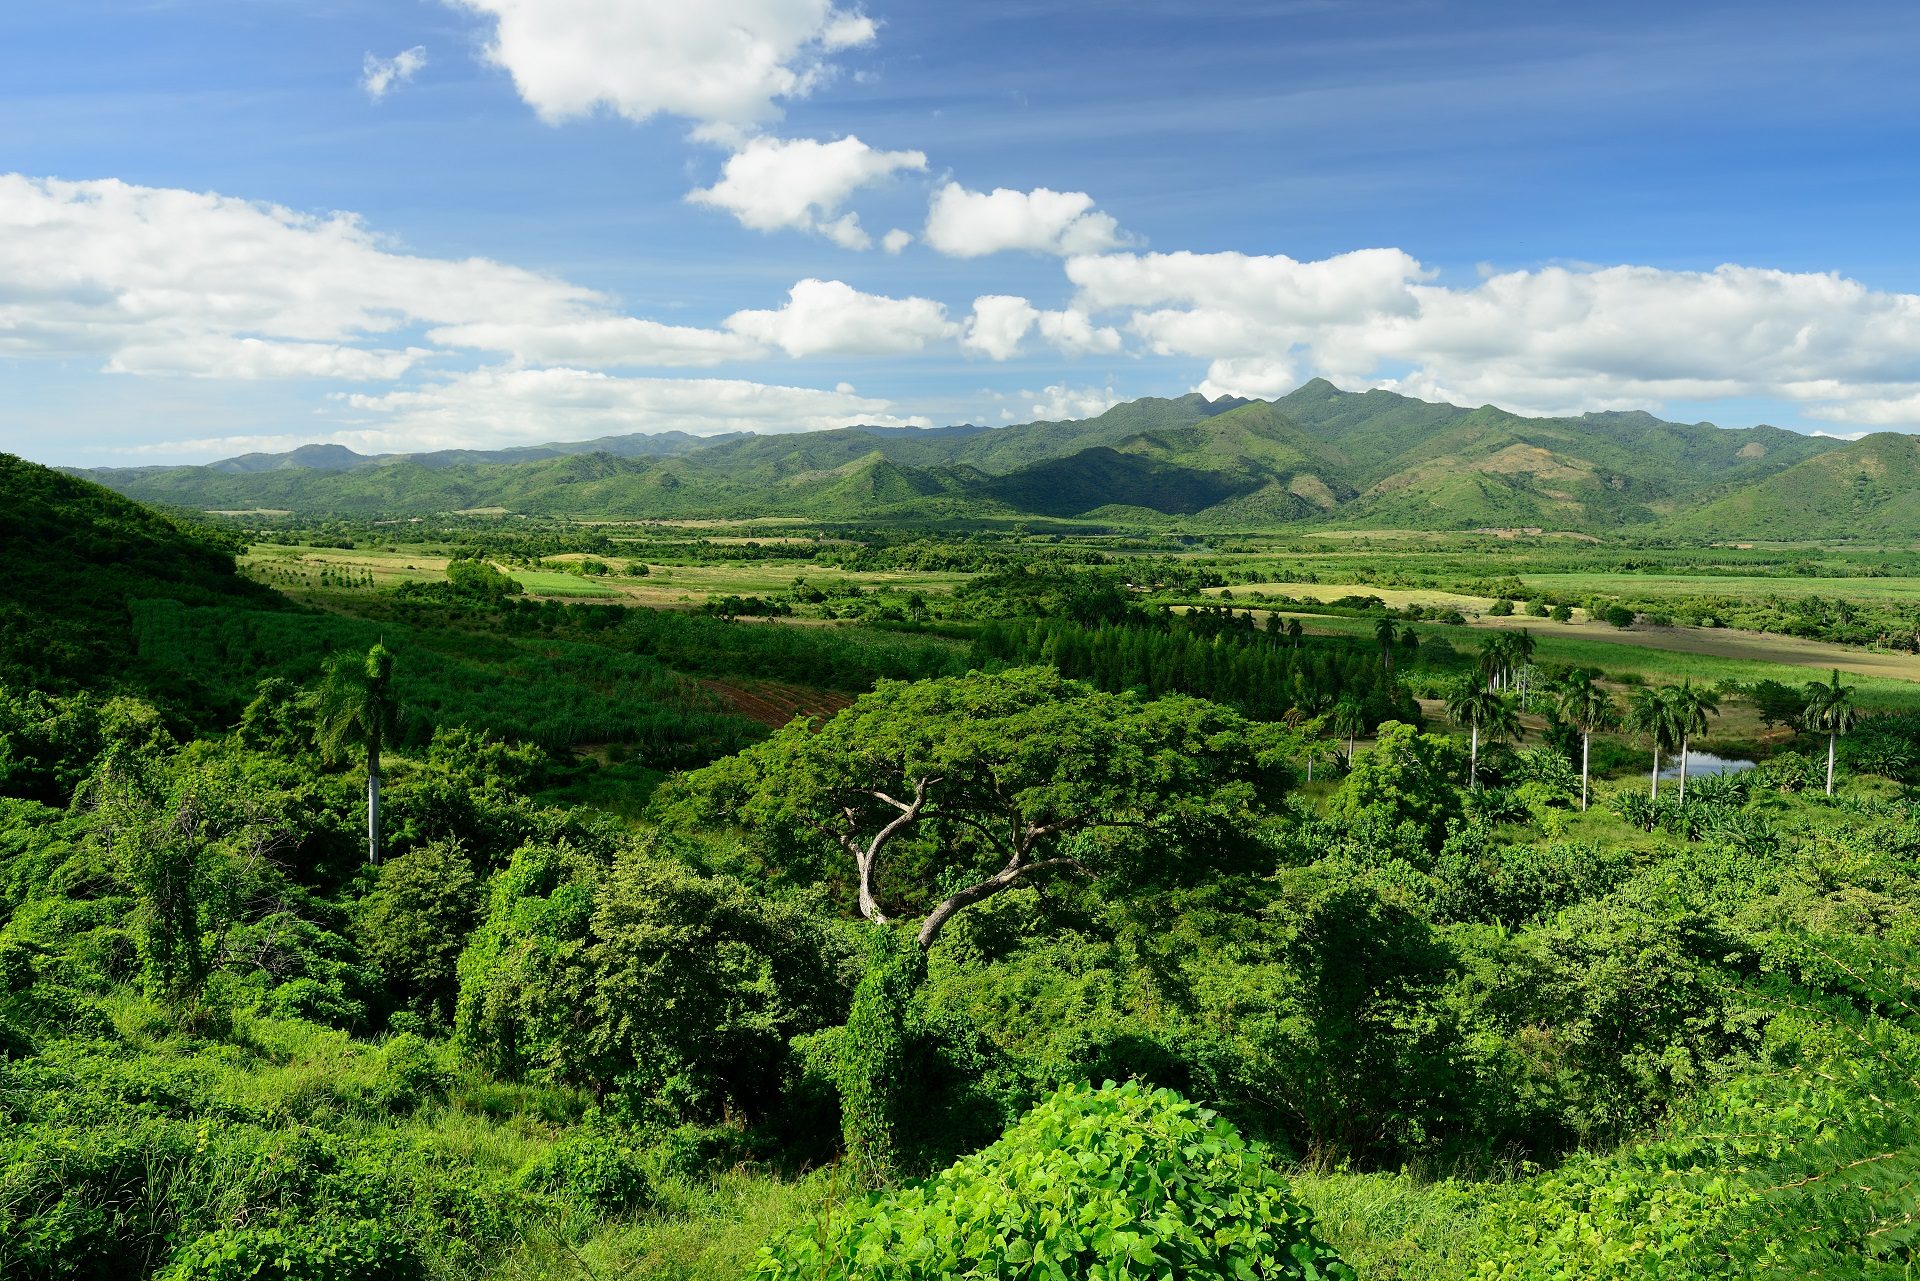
[{"xmin": 687, "ymin": 138, "xmax": 927, "ymax": 252}]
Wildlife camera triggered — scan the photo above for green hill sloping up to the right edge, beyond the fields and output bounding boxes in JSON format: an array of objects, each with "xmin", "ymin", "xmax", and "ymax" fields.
[{"xmin": 1668, "ymin": 432, "xmax": 1920, "ymax": 538}]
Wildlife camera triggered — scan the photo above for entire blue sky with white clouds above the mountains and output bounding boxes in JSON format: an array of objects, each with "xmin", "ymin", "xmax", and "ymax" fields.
[{"xmin": 0, "ymin": 0, "xmax": 1920, "ymax": 467}]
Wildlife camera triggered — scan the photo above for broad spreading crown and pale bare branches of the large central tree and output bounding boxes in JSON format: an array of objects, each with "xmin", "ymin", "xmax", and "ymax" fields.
[{"xmin": 662, "ymin": 668, "xmax": 1294, "ymax": 949}]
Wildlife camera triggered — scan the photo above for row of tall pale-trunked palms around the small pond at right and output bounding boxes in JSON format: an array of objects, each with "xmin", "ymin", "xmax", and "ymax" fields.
[{"xmin": 1446, "ymin": 630, "xmax": 1860, "ymax": 810}]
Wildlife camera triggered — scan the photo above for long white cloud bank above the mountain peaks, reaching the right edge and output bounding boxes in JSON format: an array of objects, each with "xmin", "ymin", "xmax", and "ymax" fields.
[{"xmin": 1068, "ymin": 250, "xmax": 1920, "ymax": 423}]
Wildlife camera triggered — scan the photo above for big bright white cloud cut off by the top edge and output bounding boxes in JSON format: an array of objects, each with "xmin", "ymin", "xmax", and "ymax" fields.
[{"xmin": 451, "ymin": 0, "xmax": 876, "ymax": 127}]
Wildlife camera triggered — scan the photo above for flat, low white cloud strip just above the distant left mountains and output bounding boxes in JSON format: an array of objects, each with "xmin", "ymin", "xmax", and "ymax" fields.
[{"xmin": 332, "ymin": 369, "xmax": 927, "ymax": 453}]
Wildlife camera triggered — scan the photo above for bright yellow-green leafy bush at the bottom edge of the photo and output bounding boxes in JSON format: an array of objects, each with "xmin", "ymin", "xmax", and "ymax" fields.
[{"xmin": 753, "ymin": 1083, "xmax": 1354, "ymax": 1281}]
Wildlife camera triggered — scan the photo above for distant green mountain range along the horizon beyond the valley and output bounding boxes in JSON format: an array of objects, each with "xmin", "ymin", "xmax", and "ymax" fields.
[{"xmin": 63, "ymin": 380, "xmax": 1920, "ymax": 538}]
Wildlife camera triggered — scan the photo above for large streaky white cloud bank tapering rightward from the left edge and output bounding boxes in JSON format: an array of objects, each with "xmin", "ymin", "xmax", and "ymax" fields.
[{"xmin": 0, "ymin": 175, "xmax": 779, "ymax": 380}]
